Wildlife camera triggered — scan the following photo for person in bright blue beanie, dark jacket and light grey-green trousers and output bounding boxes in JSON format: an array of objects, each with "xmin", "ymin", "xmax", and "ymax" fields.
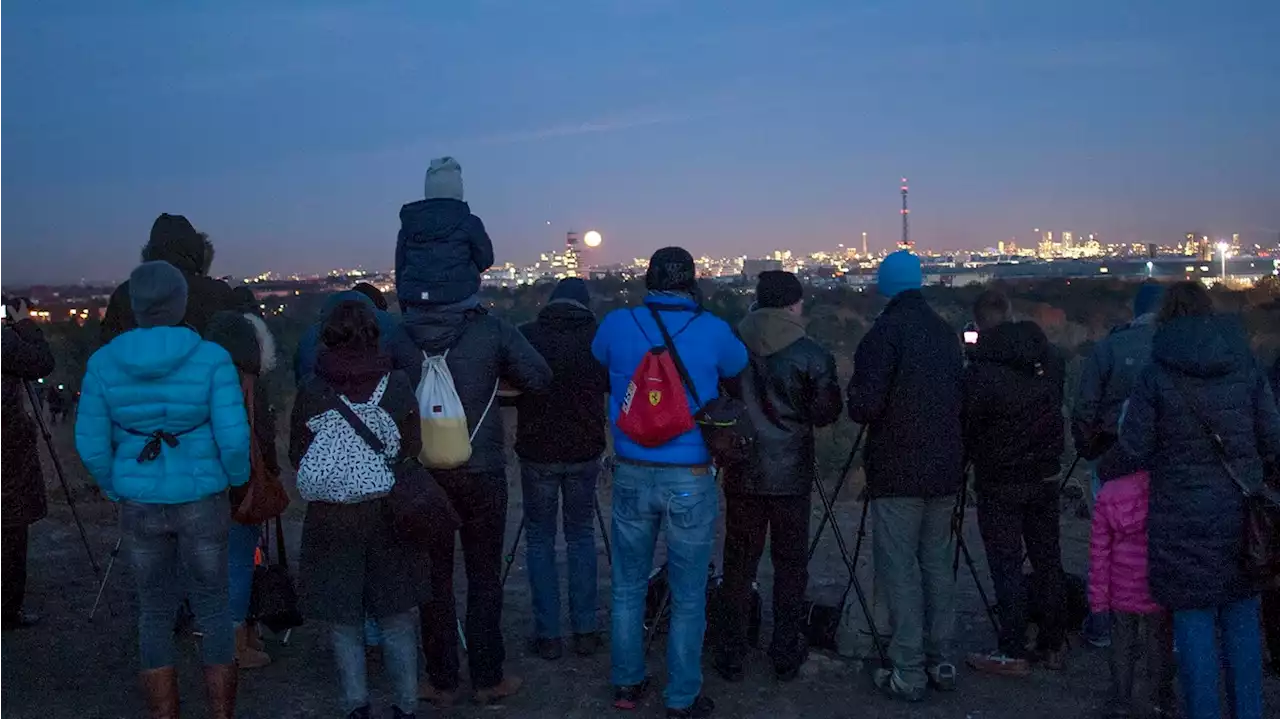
[{"xmin": 847, "ymin": 251, "xmax": 964, "ymax": 701}]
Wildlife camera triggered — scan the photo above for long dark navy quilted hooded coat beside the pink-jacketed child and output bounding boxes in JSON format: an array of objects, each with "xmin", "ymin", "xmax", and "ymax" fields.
[{"xmin": 1120, "ymin": 316, "xmax": 1280, "ymax": 610}]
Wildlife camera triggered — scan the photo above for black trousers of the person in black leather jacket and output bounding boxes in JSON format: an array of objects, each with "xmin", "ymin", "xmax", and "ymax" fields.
[{"xmin": 722, "ymin": 494, "xmax": 809, "ymax": 670}]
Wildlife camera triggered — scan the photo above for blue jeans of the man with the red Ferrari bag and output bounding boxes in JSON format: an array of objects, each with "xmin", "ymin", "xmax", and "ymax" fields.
[{"xmin": 612, "ymin": 462, "xmax": 719, "ymax": 709}]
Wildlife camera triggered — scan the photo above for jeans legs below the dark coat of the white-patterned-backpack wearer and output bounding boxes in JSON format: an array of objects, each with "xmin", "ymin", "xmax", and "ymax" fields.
[{"xmin": 333, "ymin": 610, "xmax": 417, "ymax": 714}]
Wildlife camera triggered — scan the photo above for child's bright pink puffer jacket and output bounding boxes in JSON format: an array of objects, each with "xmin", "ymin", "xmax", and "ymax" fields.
[{"xmin": 1089, "ymin": 472, "xmax": 1161, "ymax": 614}]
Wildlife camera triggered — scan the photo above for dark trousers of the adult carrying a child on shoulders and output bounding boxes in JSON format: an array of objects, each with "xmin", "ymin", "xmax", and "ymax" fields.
[{"xmin": 421, "ymin": 471, "xmax": 507, "ymax": 691}]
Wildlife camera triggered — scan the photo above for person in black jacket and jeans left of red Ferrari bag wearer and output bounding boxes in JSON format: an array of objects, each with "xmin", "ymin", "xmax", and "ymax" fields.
[{"xmin": 516, "ymin": 278, "xmax": 609, "ymax": 660}]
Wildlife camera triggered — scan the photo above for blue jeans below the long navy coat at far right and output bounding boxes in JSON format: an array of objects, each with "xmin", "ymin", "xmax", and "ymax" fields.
[{"xmin": 1174, "ymin": 596, "xmax": 1262, "ymax": 719}]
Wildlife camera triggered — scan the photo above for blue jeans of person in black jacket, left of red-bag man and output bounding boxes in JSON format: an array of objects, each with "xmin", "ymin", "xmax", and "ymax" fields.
[{"xmin": 520, "ymin": 461, "xmax": 600, "ymax": 638}]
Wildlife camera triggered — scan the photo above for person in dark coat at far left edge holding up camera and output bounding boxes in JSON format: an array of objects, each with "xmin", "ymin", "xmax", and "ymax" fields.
[{"xmin": 0, "ymin": 298, "xmax": 54, "ymax": 631}]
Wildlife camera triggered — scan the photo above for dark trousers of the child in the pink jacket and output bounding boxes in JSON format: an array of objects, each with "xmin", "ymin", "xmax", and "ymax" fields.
[{"xmin": 1111, "ymin": 612, "xmax": 1176, "ymax": 711}]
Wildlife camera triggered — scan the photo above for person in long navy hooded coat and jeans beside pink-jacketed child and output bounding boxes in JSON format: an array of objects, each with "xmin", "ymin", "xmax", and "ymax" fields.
[{"xmin": 1120, "ymin": 281, "xmax": 1280, "ymax": 719}]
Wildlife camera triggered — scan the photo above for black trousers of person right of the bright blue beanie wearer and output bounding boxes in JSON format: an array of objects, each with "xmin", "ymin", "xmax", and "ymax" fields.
[{"xmin": 978, "ymin": 480, "xmax": 1066, "ymax": 656}]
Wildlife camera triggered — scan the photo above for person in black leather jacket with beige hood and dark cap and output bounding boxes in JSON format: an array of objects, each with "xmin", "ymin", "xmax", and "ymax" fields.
[{"xmin": 716, "ymin": 271, "xmax": 844, "ymax": 682}]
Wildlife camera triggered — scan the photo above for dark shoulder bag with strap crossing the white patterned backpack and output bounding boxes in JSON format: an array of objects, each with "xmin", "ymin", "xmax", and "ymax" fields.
[{"xmin": 325, "ymin": 383, "xmax": 462, "ymax": 542}]
